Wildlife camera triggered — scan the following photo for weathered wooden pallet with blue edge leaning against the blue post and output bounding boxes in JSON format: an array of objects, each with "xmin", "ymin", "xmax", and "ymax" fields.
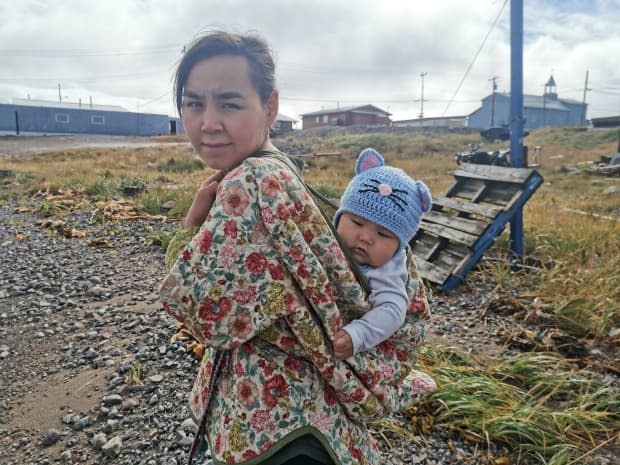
[{"xmin": 410, "ymin": 164, "xmax": 543, "ymax": 292}]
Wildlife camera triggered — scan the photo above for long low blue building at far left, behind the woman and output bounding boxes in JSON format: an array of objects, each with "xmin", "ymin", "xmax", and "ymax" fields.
[{"xmin": 0, "ymin": 99, "xmax": 184, "ymax": 136}]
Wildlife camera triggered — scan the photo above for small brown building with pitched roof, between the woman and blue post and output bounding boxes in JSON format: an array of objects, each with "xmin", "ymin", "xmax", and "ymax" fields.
[{"xmin": 301, "ymin": 105, "xmax": 392, "ymax": 129}]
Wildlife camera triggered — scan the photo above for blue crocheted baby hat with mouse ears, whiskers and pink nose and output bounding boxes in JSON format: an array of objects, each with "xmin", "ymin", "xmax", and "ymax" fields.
[{"xmin": 334, "ymin": 148, "xmax": 432, "ymax": 249}]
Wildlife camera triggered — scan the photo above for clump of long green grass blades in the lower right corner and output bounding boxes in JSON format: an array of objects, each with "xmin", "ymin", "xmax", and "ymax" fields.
[{"xmin": 410, "ymin": 346, "xmax": 620, "ymax": 465}]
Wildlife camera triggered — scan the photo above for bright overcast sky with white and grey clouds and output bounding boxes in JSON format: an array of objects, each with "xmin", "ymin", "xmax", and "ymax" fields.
[{"xmin": 0, "ymin": 0, "xmax": 620, "ymax": 120}]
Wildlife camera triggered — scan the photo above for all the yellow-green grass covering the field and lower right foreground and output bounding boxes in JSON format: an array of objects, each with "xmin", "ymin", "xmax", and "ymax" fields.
[{"xmin": 0, "ymin": 127, "xmax": 620, "ymax": 465}]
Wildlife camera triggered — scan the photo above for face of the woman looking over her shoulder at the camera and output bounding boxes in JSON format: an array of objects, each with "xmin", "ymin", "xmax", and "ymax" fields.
[{"xmin": 181, "ymin": 55, "xmax": 278, "ymax": 170}]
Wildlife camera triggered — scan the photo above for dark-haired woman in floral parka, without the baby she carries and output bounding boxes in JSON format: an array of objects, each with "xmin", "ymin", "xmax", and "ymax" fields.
[{"xmin": 160, "ymin": 32, "xmax": 435, "ymax": 465}]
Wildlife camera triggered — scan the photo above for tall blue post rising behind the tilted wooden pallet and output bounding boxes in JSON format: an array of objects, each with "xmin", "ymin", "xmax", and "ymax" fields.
[{"xmin": 510, "ymin": 0, "xmax": 525, "ymax": 257}]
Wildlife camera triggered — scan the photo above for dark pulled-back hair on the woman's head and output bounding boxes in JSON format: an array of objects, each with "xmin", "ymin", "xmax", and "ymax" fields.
[{"xmin": 174, "ymin": 31, "xmax": 275, "ymax": 115}]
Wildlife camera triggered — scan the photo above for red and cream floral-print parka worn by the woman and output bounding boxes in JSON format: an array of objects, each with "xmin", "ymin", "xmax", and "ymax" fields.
[{"xmin": 160, "ymin": 154, "xmax": 436, "ymax": 465}]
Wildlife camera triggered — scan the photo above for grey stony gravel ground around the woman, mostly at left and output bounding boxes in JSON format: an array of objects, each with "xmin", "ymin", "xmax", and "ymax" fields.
[{"xmin": 0, "ymin": 197, "xmax": 616, "ymax": 465}]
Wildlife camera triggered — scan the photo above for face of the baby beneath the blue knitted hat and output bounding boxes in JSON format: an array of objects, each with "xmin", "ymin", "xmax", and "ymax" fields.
[{"xmin": 336, "ymin": 213, "xmax": 399, "ymax": 267}]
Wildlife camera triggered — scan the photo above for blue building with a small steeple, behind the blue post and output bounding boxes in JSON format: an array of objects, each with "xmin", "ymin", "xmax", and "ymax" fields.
[{"xmin": 467, "ymin": 76, "xmax": 587, "ymax": 130}]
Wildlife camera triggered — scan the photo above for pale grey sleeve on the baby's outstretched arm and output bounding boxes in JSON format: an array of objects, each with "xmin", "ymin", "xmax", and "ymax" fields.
[{"xmin": 343, "ymin": 251, "xmax": 409, "ymax": 354}]
